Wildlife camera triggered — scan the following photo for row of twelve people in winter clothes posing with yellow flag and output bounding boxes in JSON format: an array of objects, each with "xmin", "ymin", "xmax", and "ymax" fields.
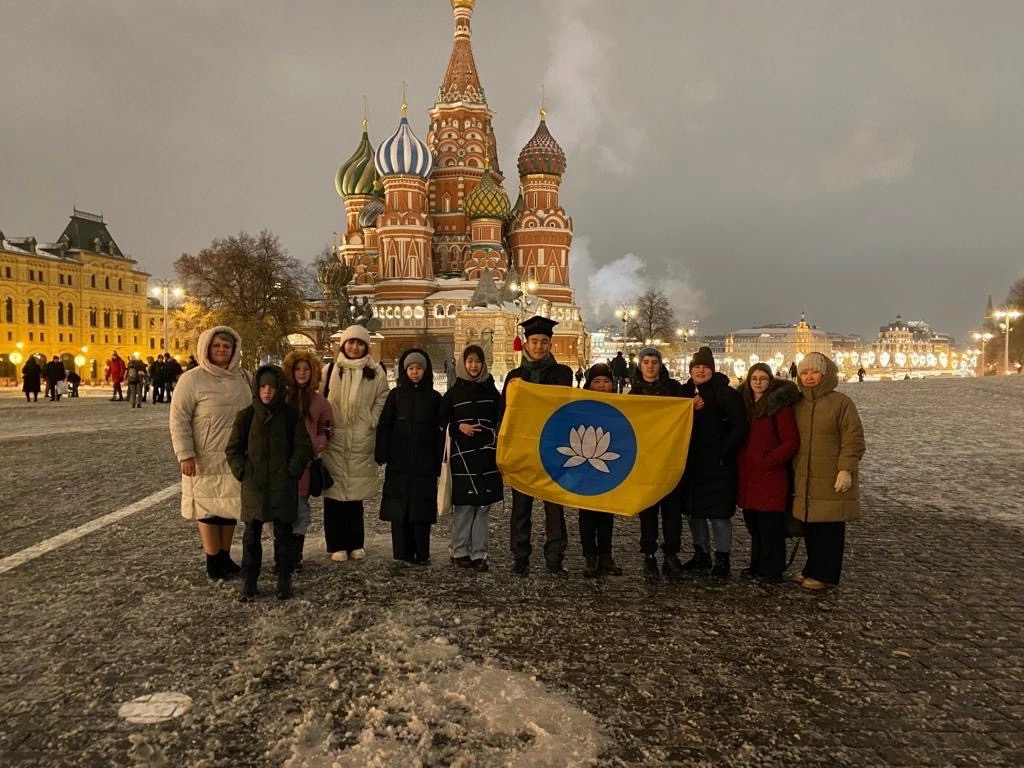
[{"xmin": 170, "ymin": 316, "xmax": 865, "ymax": 600}]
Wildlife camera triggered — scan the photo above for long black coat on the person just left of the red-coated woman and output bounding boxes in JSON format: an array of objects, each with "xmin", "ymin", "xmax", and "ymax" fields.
[{"xmin": 680, "ymin": 372, "xmax": 746, "ymax": 519}]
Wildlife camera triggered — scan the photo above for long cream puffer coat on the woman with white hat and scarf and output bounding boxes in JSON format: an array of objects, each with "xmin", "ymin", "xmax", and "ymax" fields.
[{"xmin": 321, "ymin": 362, "xmax": 389, "ymax": 502}]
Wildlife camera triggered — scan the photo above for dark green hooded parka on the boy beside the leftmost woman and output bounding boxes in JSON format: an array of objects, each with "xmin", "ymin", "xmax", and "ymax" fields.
[{"xmin": 225, "ymin": 366, "xmax": 313, "ymax": 522}]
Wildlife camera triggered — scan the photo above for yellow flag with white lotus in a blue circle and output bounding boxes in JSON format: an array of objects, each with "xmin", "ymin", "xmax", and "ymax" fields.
[{"xmin": 498, "ymin": 379, "xmax": 693, "ymax": 515}]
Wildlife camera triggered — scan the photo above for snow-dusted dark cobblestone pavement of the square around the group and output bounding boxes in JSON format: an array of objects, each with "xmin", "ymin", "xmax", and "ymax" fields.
[{"xmin": 0, "ymin": 377, "xmax": 1024, "ymax": 768}]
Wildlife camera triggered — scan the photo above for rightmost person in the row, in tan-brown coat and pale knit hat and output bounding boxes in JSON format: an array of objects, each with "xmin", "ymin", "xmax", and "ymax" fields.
[{"xmin": 793, "ymin": 352, "xmax": 865, "ymax": 590}]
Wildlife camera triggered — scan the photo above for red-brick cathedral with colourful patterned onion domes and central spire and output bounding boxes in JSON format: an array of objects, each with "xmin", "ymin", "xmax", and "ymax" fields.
[{"xmin": 327, "ymin": 0, "xmax": 590, "ymax": 376}]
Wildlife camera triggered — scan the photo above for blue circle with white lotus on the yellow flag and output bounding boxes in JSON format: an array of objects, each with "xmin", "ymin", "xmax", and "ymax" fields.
[{"xmin": 540, "ymin": 400, "xmax": 637, "ymax": 496}]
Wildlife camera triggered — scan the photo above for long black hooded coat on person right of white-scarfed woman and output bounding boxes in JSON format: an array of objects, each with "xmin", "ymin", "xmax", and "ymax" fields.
[{"xmin": 375, "ymin": 349, "xmax": 443, "ymax": 523}]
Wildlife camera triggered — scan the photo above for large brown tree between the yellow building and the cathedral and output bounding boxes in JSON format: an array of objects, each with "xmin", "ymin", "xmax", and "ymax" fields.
[{"xmin": 174, "ymin": 229, "xmax": 305, "ymax": 370}]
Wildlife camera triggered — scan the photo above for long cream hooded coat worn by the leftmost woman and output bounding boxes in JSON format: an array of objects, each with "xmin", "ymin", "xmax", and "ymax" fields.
[{"xmin": 171, "ymin": 326, "xmax": 253, "ymax": 520}]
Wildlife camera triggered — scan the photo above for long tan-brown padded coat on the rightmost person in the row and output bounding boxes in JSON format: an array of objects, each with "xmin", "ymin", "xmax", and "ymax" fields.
[{"xmin": 793, "ymin": 360, "xmax": 865, "ymax": 522}]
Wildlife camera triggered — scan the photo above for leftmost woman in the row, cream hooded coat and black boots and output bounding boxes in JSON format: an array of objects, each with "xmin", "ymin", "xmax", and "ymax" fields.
[{"xmin": 171, "ymin": 326, "xmax": 253, "ymax": 579}]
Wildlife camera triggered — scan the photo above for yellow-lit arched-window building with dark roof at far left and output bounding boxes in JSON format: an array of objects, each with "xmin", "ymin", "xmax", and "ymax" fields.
[{"xmin": 0, "ymin": 209, "xmax": 163, "ymax": 381}]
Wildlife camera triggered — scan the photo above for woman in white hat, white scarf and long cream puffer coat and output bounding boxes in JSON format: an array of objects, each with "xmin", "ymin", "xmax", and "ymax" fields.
[{"xmin": 321, "ymin": 326, "xmax": 388, "ymax": 562}]
